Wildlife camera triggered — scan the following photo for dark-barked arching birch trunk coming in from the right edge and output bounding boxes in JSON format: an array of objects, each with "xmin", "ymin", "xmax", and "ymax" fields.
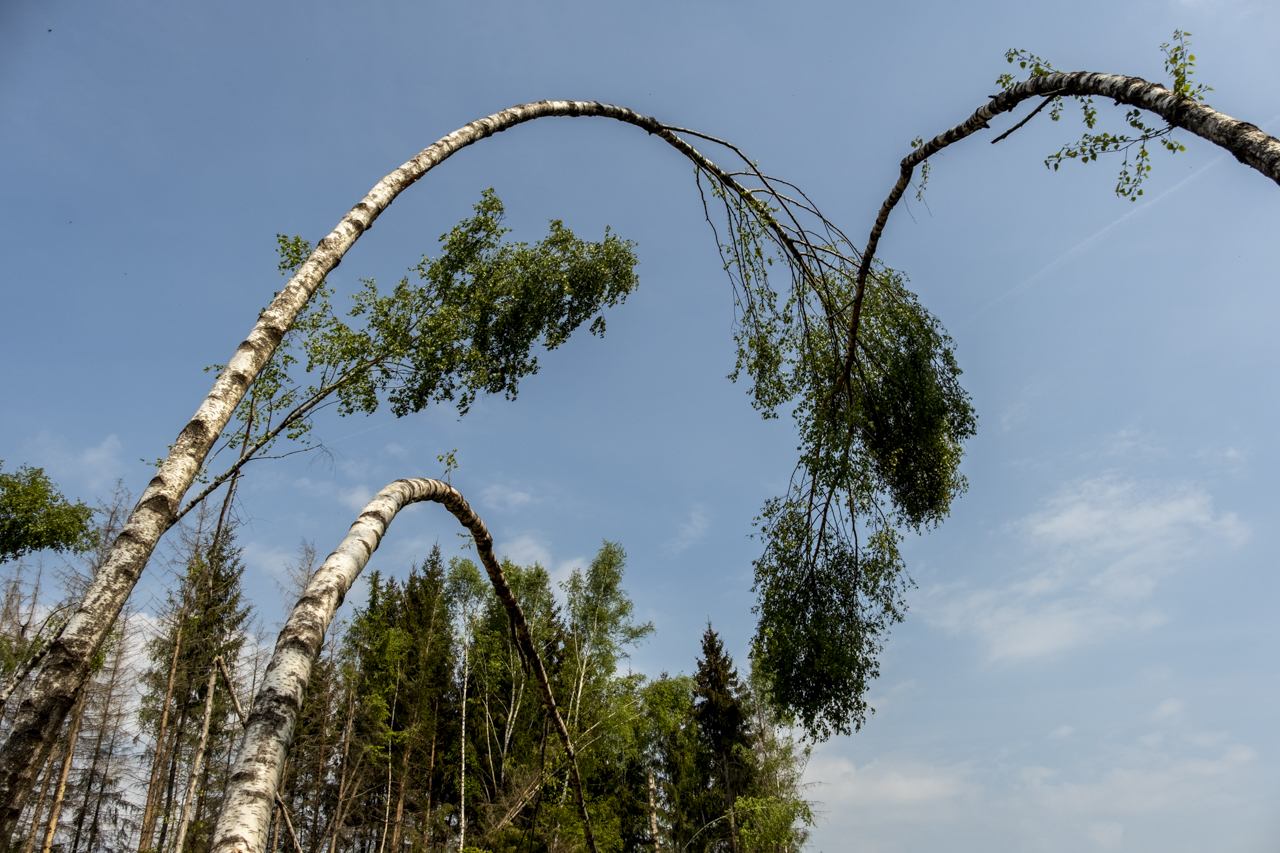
[{"xmin": 846, "ymin": 72, "xmax": 1280, "ymax": 361}]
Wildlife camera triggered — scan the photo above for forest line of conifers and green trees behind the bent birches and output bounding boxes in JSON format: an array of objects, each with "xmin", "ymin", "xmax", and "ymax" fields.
[{"xmin": 0, "ymin": 496, "xmax": 814, "ymax": 853}]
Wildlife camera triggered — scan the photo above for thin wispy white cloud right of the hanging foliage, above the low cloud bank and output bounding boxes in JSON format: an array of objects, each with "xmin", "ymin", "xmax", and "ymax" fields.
[{"xmin": 920, "ymin": 476, "xmax": 1248, "ymax": 662}]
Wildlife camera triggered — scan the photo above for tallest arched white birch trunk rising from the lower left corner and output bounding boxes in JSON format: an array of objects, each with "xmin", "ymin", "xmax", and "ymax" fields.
[{"xmin": 0, "ymin": 101, "xmax": 791, "ymax": 839}]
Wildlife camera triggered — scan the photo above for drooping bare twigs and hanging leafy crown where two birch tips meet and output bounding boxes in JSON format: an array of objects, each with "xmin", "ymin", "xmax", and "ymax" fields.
[{"xmin": 672, "ymin": 128, "xmax": 975, "ymax": 739}]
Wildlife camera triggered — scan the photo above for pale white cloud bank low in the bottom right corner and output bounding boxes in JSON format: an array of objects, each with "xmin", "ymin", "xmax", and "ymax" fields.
[{"xmin": 805, "ymin": 726, "xmax": 1267, "ymax": 853}]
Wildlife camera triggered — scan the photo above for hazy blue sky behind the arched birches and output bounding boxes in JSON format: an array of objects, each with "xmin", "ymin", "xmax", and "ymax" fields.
[{"xmin": 0, "ymin": 0, "xmax": 1280, "ymax": 853}]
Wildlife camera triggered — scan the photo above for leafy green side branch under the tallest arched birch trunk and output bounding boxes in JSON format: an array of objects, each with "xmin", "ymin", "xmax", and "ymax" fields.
[{"xmin": 188, "ymin": 190, "xmax": 639, "ymax": 508}]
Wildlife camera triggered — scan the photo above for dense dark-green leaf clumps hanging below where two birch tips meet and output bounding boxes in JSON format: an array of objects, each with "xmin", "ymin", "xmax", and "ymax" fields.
[{"xmin": 754, "ymin": 270, "xmax": 975, "ymax": 738}]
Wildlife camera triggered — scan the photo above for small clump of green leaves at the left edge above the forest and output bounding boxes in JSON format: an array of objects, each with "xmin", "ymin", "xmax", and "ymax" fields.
[{"xmin": 0, "ymin": 461, "xmax": 93, "ymax": 562}]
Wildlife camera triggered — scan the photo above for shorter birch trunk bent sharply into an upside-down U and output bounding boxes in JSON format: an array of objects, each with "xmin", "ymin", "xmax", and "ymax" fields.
[{"xmin": 210, "ymin": 479, "xmax": 595, "ymax": 853}]
